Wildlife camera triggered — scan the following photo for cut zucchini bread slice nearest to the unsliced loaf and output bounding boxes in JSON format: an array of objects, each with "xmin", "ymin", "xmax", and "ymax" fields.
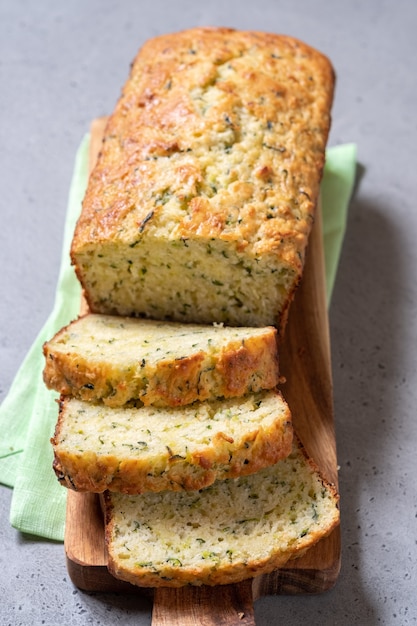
[{"xmin": 43, "ymin": 314, "xmax": 279, "ymax": 407}]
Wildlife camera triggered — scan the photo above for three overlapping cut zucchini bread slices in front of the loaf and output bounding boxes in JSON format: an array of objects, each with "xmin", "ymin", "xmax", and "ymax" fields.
[{"xmin": 44, "ymin": 314, "xmax": 339, "ymax": 586}]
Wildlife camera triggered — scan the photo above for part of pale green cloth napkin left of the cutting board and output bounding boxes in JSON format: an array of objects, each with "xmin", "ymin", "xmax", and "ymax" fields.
[{"xmin": 0, "ymin": 135, "xmax": 89, "ymax": 540}]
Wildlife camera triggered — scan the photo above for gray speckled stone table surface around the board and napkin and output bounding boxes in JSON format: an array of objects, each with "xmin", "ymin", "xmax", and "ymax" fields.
[{"xmin": 0, "ymin": 0, "xmax": 417, "ymax": 626}]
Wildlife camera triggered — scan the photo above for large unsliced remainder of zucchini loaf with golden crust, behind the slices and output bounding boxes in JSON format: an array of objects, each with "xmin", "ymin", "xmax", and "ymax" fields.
[{"xmin": 71, "ymin": 28, "xmax": 334, "ymax": 328}]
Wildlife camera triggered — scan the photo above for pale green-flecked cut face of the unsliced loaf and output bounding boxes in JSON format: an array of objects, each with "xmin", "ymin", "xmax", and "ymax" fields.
[{"xmin": 72, "ymin": 235, "xmax": 299, "ymax": 327}]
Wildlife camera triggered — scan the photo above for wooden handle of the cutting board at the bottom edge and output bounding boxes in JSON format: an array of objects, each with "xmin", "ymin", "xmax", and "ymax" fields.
[{"xmin": 151, "ymin": 580, "xmax": 255, "ymax": 626}]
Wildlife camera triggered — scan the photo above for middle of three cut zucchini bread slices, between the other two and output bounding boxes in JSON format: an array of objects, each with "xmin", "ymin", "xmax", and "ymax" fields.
[{"xmin": 52, "ymin": 391, "xmax": 293, "ymax": 493}]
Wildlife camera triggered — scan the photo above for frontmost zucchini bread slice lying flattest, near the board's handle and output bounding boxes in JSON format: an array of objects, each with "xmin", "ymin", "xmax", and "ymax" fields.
[{"xmin": 103, "ymin": 440, "xmax": 339, "ymax": 587}]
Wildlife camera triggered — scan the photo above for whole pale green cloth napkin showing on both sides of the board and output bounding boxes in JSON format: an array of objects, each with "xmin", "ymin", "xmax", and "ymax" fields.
[{"xmin": 0, "ymin": 135, "xmax": 356, "ymax": 541}]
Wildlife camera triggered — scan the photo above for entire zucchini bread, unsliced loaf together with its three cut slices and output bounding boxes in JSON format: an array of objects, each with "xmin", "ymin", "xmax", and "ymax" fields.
[{"xmin": 44, "ymin": 28, "xmax": 339, "ymax": 587}]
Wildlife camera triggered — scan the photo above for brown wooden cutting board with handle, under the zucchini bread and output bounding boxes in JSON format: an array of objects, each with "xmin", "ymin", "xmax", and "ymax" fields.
[{"xmin": 65, "ymin": 118, "xmax": 341, "ymax": 626}]
